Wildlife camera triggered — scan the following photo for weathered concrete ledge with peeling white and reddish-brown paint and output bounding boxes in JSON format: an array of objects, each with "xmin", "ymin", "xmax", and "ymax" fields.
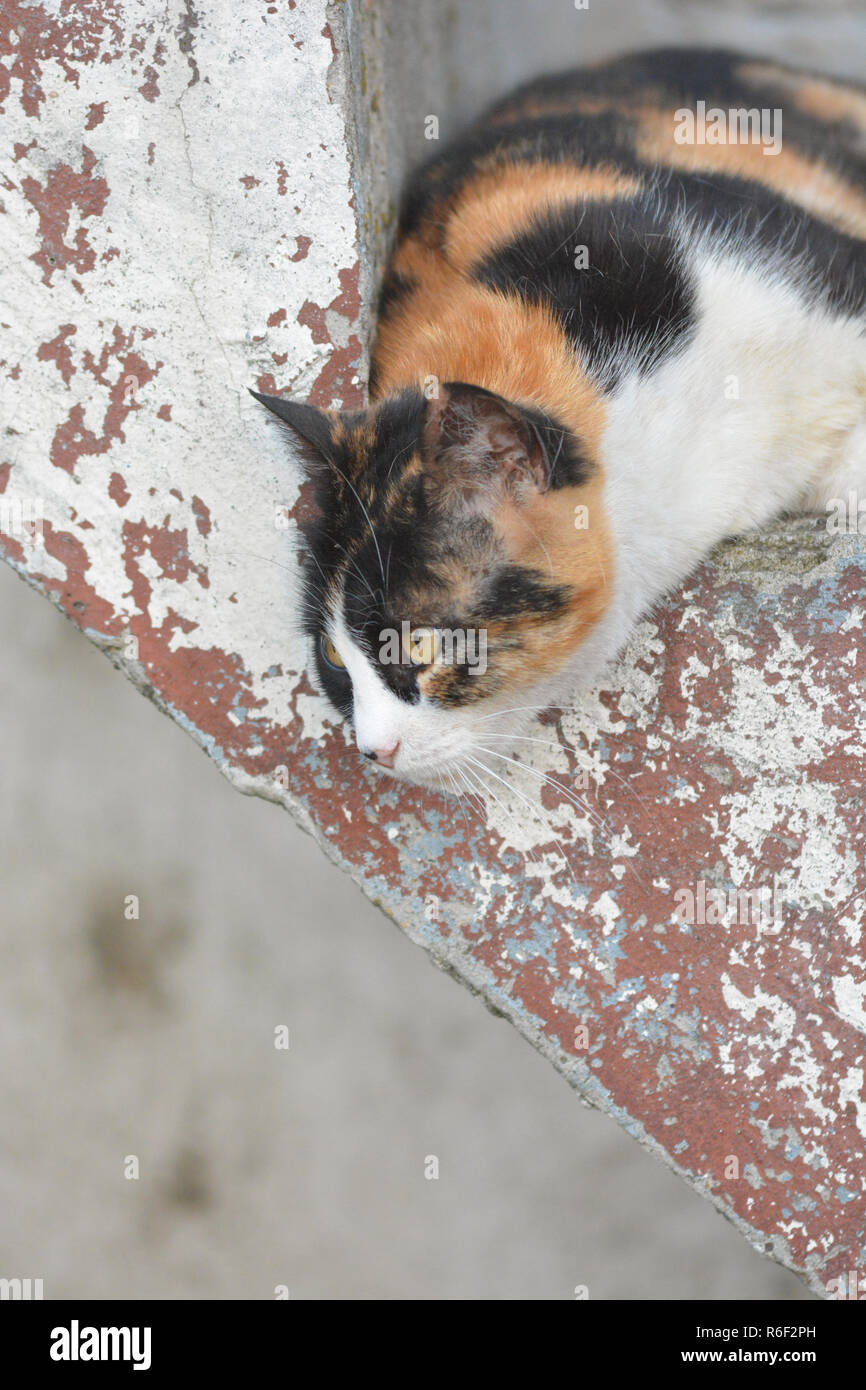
[{"xmin": 0, "ymin": 0, "xmax": 866, "ymax": 1297}]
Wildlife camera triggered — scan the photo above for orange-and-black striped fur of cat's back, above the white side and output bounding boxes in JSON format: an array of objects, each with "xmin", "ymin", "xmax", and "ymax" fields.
[{"xmin": 371, "ymin": 49, "xmax": 866, "ymax": 395}]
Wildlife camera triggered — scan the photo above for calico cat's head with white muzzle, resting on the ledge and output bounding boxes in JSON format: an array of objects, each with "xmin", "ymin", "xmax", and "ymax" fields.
[{"xmin": 253, "ymin": 382, "xmax": 612, "ymax": 787}]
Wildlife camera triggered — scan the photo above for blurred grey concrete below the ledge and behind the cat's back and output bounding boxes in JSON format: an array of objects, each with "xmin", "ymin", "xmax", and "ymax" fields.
[{"xmin": 0, "ymin": 0, "xmax": 863, "ymax": 1300}]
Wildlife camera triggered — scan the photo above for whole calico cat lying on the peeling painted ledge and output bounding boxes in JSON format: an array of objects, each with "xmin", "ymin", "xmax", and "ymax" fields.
[{"xmin": 259, "ymin": 50, "xmax": 866, "ymax": 787}]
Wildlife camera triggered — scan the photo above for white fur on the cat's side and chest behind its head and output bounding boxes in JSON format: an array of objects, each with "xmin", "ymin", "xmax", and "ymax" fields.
[{"xmin": 602, "ymin": 247, "xmax": 866, "ymax": 642}]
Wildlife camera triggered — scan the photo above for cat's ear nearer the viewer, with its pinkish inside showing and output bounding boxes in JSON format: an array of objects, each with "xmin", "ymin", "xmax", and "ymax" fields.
[{"xmin": 424, "ymin": 381, "xmax": 552, "ymax": 509}]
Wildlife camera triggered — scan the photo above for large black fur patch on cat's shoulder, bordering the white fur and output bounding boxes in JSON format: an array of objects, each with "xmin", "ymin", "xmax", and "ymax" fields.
[{"xmin": 475, "ymin": 172, "xmax": 866, "ymax": 391}]
